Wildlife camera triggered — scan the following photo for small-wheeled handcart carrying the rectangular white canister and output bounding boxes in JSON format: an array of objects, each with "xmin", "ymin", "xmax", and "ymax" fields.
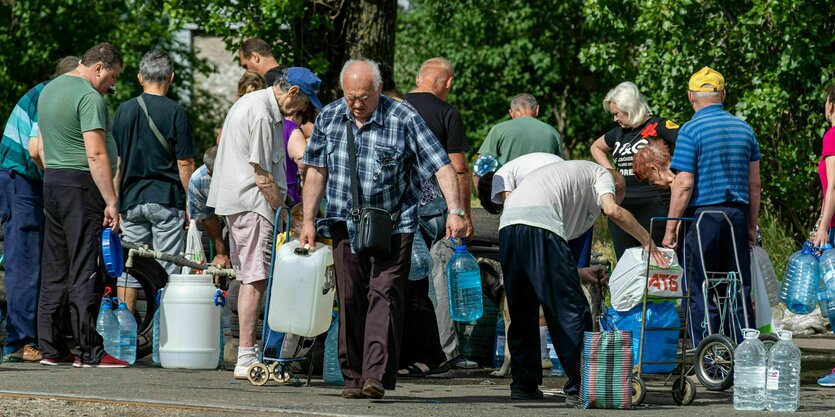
[{"xmin": 246, "ymin": 207, "xmax": 316, "ymax": 386}]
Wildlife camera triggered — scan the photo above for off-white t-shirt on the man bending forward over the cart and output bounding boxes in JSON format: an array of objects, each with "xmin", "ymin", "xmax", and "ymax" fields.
[{"xmin": 499, "ymin": 161, "xmax": 615, "ymax": 241}]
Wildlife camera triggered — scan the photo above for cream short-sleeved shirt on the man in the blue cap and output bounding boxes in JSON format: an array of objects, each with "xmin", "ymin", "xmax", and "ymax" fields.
[{"xmin": 207, "ymin": 88, "xmax": 287, "ymax": 223}]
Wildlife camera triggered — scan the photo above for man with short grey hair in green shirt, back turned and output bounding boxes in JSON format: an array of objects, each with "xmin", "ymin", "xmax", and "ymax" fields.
[{"xmin": 476, "ymin": 93, "xmax": 563, "ymax": 170}]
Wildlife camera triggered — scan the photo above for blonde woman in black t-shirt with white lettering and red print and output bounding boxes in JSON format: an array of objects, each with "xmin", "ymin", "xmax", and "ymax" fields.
[{"xmin": 591, "ymin": 81, "xmax": 678, "ymax": 259}]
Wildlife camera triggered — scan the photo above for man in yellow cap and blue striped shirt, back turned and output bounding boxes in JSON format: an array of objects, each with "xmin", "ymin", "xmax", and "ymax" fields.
[{"xmin": 664, "ymin": 67, "xmax": 761, "ymax": 346}]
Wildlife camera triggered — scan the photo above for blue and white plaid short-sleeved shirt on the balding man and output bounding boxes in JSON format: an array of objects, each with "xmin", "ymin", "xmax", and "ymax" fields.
[{"xmin": 304, "ymin": 95, "xmax": 449, "ymax": 241}]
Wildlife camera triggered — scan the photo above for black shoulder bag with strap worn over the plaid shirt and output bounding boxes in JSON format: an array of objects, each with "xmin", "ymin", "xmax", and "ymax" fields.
[{"xmin": 345, "ymin": 119, "xmax": 399, "ymax": 257}]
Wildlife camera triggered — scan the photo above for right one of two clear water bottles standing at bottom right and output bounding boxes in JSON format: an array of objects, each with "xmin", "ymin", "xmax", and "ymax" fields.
[{"xmin": 764, "ymin": 330, "xmax": 800, "ymax": 411}]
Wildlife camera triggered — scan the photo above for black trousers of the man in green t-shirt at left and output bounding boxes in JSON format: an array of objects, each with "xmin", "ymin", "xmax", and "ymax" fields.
[{"xmin": 38, "ymin": 169, "xmax": 105, "ymax": 363}]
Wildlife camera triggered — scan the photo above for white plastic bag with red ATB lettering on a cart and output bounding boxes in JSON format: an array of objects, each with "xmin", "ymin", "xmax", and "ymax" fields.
[{"xmin": 609, "ymin": 247, "xmax": 683, "ymax": 311}]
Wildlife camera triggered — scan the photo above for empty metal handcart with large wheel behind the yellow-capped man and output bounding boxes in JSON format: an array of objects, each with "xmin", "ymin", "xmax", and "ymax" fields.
[{"xmin": 694, "ymin": 210, "xmax": 777, "ymax": 391}]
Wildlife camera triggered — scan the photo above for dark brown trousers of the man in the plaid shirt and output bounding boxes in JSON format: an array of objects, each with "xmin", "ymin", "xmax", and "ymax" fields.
[{"xmin": 331, "ymin": 223, "xmax": 413, "ymax": 389}]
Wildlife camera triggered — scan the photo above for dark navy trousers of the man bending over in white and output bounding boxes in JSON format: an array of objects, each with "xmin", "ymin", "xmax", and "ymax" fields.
[{"xmin": 499, "ymin": 225, "xmax": 592, "ymax": 395}]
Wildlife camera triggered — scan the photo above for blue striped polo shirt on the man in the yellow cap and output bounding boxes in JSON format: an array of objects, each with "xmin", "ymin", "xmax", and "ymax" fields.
[{"xmin": 670, "ymin": 104, "xmax": 762, "ymax": 207}]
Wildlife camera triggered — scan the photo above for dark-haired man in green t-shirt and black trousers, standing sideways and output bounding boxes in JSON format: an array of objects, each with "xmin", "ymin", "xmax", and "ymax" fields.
[{"xmin": 38, "ymin": 43, "xmax": 128, "ymax": 368}]
